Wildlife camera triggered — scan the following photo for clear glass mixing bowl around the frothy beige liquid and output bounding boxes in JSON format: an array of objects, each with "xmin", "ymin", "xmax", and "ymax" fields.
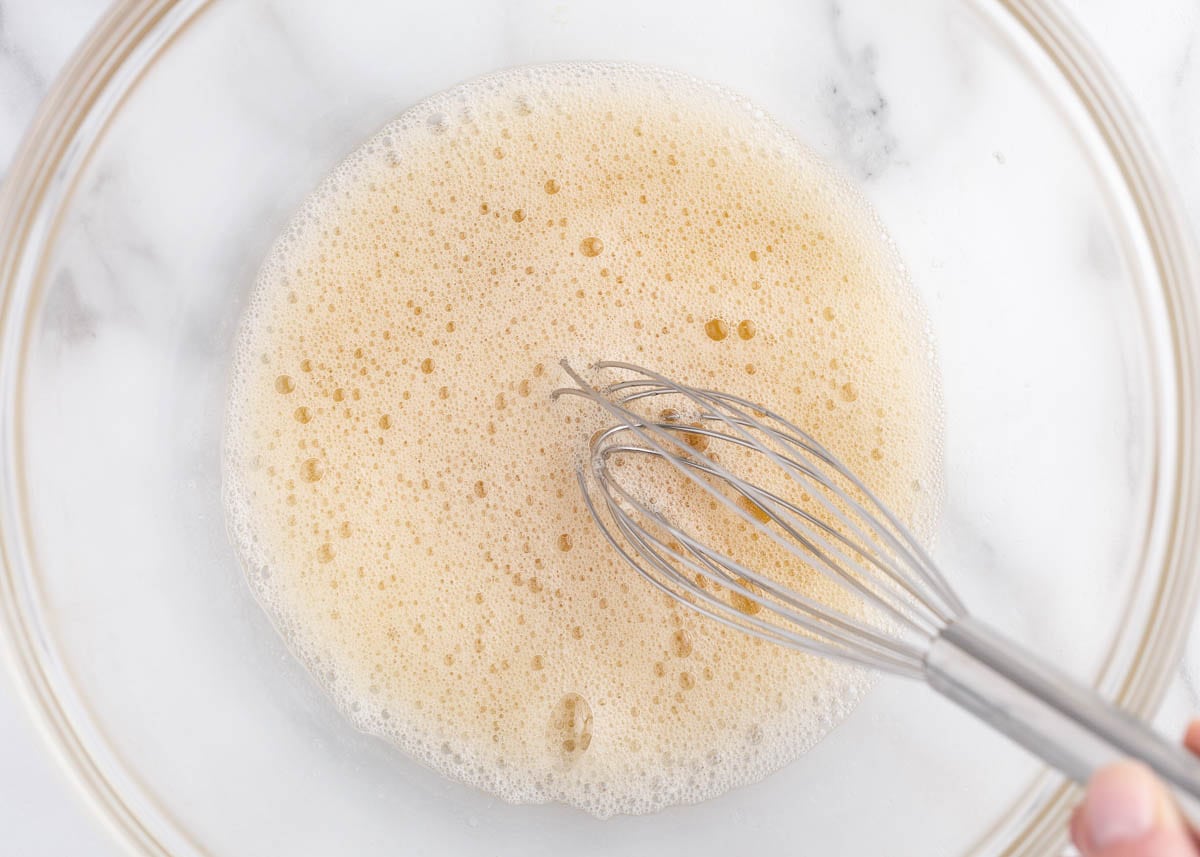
[{"xmin": 0, "ymin": 0, "xmax": 1200, "ymax": 857}]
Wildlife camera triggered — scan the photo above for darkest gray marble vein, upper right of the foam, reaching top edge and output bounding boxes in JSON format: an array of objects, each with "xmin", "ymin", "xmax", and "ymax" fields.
[{"xmin": 826, "ymin": 0, "xmax": 896, "ymax": 179}]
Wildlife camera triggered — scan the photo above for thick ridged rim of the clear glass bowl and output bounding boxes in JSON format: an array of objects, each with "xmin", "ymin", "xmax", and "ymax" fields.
[{"xmin": 0, "ymin": 0, "xmax": 1200, "ymax": 857}]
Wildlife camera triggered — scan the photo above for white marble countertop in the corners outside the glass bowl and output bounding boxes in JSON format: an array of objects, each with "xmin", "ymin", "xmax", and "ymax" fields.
[{"xmin": 0, "ymin": 0, "xmax": 1200, "ymax": 857}]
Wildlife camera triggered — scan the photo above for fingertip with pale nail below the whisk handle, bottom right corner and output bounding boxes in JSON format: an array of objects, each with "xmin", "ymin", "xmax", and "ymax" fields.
[{"xmin": 1072, "ymin": 762, "xmax": 1200, "ymax": 857}]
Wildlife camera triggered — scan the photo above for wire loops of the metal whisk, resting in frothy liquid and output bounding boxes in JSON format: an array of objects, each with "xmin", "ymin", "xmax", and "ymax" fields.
[{"xmin": 554, "ymin": 361, "xmax": 962, "ymax": 675}]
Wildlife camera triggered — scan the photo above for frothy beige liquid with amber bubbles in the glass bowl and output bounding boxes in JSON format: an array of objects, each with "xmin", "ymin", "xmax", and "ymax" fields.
[{"xmin": 226, "ymin": 65, "xmax": 938, "ymax": 815}]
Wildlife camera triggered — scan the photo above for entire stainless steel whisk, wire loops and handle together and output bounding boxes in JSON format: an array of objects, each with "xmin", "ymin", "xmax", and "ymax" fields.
[{"xmin": 553, "ymin": 360, "xmax": 1200, "ymax": 820}]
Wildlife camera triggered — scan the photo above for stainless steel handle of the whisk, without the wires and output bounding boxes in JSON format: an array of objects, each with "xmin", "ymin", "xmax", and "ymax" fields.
[{"xmin": 925, "ymin": 617, "xmax": 1200, "ymax": 822}]
